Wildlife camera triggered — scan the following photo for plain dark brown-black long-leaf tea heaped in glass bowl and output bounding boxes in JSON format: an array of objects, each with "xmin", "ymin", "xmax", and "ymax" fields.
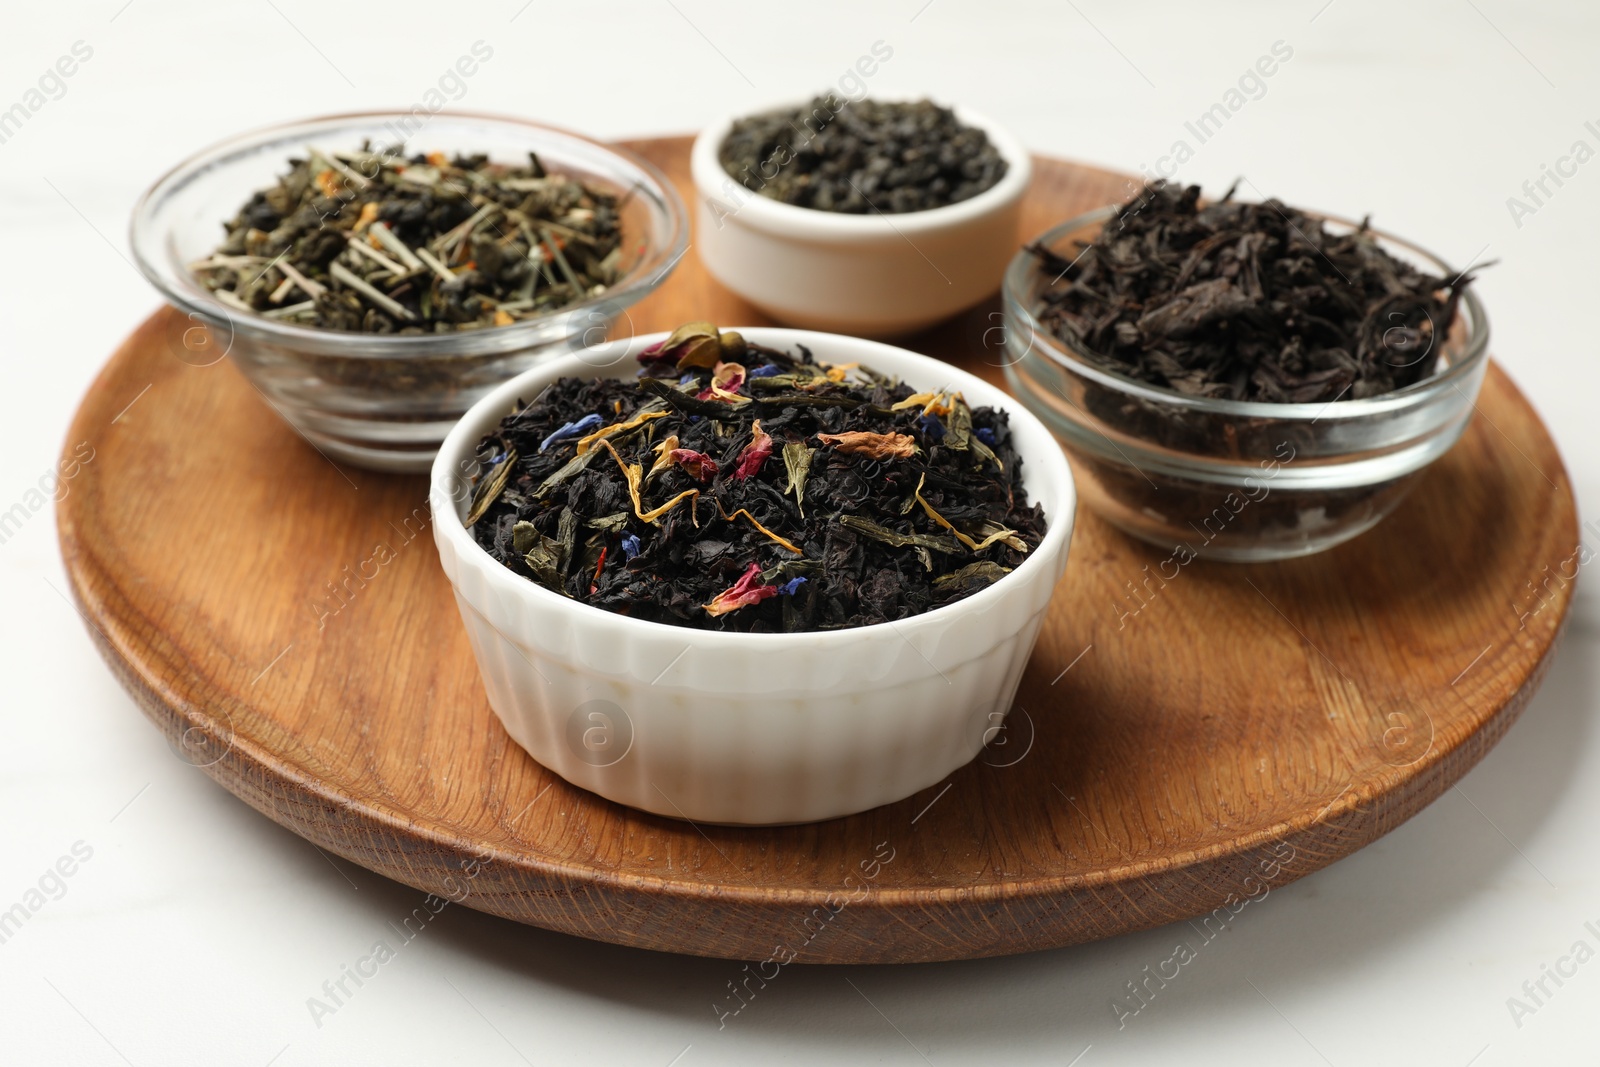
[{"xmin": 1032, "ymin": 182, "xmax": 1472, "ymax": 403}]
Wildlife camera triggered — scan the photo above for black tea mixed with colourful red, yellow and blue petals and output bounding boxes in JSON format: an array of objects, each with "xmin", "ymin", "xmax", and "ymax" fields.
[{"xmin": 467, "ymin": 323, "xmax": 1045, "ymax": 632}]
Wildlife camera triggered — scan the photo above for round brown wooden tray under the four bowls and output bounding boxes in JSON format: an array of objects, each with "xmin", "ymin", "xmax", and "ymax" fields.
[{"xmin": 59, "ymin": 138, "xmax": 1578, "ymax": 965}]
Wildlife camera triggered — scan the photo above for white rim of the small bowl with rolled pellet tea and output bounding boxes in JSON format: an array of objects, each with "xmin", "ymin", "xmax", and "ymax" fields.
[{"xmin": 690, "ymin": 96, "xmax": 1034, "ymax": 242}]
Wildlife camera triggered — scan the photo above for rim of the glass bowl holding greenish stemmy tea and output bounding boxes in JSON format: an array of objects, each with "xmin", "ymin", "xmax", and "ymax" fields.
[{"xmin": 128, "ymin": 109, "xmax": 690, "ymax": 360}]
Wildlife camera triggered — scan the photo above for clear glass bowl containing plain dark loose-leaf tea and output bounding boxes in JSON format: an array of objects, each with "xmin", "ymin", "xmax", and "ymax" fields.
[{"xmin": 1003, "ymin": 208, "xmax": 1488, "ymax": 563}]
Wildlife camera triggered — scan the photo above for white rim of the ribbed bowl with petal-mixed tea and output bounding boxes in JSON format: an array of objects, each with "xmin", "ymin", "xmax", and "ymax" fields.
[{"xmin": 427, "ymin": 326, "xmax": 1078, "ymax": 651}]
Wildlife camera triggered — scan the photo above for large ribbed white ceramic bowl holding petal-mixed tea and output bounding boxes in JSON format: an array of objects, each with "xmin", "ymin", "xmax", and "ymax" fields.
[{"xmin": 429, "ymin": 328, "xmax": 1077, "ymax": 824}]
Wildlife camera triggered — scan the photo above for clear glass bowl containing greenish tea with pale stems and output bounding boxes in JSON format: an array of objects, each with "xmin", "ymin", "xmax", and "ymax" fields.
[{"xmin": 131, "ymin": 112, "xmax": 688, "ymax": 472}]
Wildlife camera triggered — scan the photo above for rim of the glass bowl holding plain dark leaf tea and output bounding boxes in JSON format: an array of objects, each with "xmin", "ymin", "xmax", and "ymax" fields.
[{"xmin": 1000, "ymin": 203, "xmax": 1490, "ymax": 421}]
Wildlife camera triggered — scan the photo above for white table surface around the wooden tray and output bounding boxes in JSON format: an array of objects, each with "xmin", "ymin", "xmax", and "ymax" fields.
[{"xmin": 0, "ymin": 0, "xmax": 1600, "ymax": 1067}]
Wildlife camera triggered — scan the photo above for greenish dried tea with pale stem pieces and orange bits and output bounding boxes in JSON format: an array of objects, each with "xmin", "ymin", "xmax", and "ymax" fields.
[{"xmin": 190, "ymin": 149, "xmax": 622, "ymax": 334}]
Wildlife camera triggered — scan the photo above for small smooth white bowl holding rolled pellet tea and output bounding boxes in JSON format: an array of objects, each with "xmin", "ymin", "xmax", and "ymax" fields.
[{"xmin": 690, "ymin": 107, "xmax": 1034, "ymax": 338}]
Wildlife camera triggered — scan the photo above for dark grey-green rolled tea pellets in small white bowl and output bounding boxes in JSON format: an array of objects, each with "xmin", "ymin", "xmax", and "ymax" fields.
[{"xmin": 718, "ymin": 94, "xmax": 1006, "ymax": 214}]
